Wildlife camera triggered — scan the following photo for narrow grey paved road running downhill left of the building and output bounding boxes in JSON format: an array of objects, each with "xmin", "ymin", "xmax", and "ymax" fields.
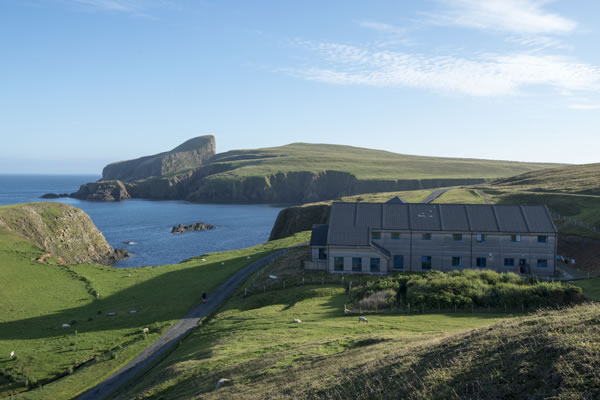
[{"xmin": 77, "ymin": 249, "xmax": 296, "ymax": 400}]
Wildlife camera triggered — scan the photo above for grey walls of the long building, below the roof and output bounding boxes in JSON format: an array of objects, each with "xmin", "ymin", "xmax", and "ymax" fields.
[{"xmin": 313, "ymin": 231, "xmax": 556, "ymax": 276}]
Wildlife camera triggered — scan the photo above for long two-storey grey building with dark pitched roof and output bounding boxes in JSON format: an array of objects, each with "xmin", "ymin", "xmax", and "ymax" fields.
[{"xmin": 306, "ymin": 199, "xmax": 557, "ymax": 276}]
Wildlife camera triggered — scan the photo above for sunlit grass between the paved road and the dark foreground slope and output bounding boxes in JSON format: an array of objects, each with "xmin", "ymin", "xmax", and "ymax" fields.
[{"xmin": 120, "ymin": 285, "xmax": 507, "ymax": 399}]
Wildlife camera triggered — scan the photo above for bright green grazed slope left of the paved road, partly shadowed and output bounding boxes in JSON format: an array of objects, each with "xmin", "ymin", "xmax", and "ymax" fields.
[{"xmin": 0, "ymin": 219, "xmax": 307, "ymax": 398}]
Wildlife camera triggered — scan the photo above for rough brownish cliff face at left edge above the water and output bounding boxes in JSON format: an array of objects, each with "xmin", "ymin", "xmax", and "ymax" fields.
[{"xmin": 0, "ymin": 202, "xmax": 126, "ymax": 265}]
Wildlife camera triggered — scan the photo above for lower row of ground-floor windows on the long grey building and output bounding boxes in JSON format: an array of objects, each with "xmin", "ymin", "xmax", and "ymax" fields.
[{"xmin": 333, "ymin": 255, "xmax": 548, "ymax": 272}]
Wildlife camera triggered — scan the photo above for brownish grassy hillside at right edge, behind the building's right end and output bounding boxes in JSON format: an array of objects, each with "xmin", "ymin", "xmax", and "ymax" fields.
[{"xmin": 492, "ymin": 163, "xmax": 600, "ymax": 195}]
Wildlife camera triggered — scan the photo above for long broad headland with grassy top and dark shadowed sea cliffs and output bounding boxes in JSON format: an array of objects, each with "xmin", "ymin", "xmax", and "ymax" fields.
[{"xmin": 67, "ymin": 143, "xmax": 557, "ymax": 203}]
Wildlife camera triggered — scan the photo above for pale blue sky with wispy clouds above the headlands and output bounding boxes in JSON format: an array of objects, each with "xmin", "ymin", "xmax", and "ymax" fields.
[{"xmin": 0, "ymin": 0, "xmax": 600, "ymax": 174}]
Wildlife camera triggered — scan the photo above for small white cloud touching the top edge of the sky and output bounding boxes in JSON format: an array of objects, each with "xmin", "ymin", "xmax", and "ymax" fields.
[{"xmin": 430, "ymin": 0, "xmax": 577, "ymax": 34}]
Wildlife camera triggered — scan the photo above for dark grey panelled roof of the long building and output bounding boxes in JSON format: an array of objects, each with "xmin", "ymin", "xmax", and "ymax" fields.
[{"xmin": 328, "ymin": 203, "xmax": 556, "ymax": 246}]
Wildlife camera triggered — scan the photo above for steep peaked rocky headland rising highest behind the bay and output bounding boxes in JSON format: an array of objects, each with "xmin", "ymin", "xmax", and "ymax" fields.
[{"xmin": 102, "ymin": 135, "xmax": 216, "ymax": 182}]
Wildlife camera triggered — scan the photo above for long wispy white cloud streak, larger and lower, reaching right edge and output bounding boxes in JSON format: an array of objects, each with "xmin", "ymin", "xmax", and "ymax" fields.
[{"xmin": 291, "ymin": 43, "xmax": 600, "ymax": 96}]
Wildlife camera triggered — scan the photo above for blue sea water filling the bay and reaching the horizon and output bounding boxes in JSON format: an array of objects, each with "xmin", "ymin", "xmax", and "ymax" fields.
[{"xmin": 0, "ymin": 175, "xmax": 281, "ymax": 267}]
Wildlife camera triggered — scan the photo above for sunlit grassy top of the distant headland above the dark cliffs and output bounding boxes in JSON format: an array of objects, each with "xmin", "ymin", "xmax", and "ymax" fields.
[{"xmin": 204, "ymin": 143, "xmax": 556, "ymax": 179}]
